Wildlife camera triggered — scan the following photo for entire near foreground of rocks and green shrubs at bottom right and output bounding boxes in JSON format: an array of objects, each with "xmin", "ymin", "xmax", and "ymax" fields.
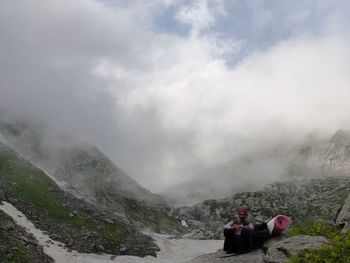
[{"xmin": 189, "ymin": 191, "xmax": 350, "ymax": 263}]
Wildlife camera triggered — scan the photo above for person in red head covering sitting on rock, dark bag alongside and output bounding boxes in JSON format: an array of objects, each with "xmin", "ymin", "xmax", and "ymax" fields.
[{"xmin": 224, "ymin": 207, "xmax": 269, "ymax": 253}]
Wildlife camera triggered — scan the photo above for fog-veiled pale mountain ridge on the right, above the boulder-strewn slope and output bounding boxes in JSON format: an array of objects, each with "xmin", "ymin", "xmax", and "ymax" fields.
[{"xmin": 164, "ymin": 130, "xmax": 350, "ymax": 205}]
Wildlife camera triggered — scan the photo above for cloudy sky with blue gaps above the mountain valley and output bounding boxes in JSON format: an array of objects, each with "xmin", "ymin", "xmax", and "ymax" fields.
[{"xmin": 0, "ymin": 0, "xmax": 350, "ymax": 192}]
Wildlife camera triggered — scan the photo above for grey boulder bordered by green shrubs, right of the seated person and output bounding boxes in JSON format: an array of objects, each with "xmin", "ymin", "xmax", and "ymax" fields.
[{"xmin": 264, "ymin": 235, "xmax": 329, "ymax": 263}]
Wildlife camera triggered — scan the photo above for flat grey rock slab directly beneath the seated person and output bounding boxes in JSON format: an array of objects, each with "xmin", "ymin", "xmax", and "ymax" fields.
[{"xmin": 188, "ymin": 249, "xmax": 265, "ymax": 263}]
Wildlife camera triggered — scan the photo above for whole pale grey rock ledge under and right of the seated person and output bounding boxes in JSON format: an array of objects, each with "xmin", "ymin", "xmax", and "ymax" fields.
[{"xmin": 189, "ymin": 235, "xmax": 329, "ymax": 263}]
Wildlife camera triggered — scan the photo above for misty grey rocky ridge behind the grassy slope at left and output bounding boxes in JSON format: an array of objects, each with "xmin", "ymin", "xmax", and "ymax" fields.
[{"xmin": 0, "ymin": 121, "xmax": 184, "ymax": 234}]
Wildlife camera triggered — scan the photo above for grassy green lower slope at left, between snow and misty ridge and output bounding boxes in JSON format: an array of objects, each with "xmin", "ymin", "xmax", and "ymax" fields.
[{"xmin": 0, "ymin": 143, "xmax": 157, "ymax": 256}]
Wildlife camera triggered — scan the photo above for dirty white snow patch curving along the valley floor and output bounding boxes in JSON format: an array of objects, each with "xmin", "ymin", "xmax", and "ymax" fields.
[{"xmin": 0, "ymin": 201, "xmax": 223, "ymax": 263}]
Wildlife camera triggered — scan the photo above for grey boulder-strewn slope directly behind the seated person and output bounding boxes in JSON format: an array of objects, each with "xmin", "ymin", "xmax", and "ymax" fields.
[{"xmin": 178, "ymin": 176, "xmax": 350, "ymax": 238}]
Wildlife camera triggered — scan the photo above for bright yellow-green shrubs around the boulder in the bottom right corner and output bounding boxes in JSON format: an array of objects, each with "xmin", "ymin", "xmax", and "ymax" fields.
[{"xmin": 288, "ymin": 220, "xmax": 350, "ymax": 263}]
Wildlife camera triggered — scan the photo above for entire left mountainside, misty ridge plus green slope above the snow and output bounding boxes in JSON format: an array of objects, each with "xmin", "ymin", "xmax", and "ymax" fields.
[{"xmin": 0, "ymin": 122, "xmax": 185, "ymax": 256}]
